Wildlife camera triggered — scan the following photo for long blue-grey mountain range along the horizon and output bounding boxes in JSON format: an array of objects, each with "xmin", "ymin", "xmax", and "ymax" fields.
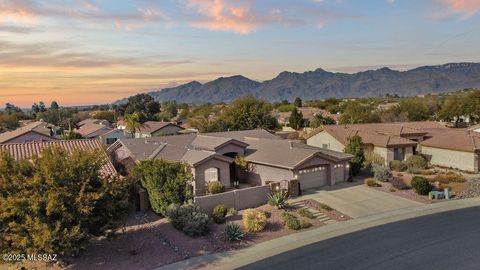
[{"xmin": 114, "ymin": 63, "xmax": 480, "ymax": 103}]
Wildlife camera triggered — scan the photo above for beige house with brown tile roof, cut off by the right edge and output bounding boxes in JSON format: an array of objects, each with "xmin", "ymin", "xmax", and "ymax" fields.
[{"xmin": 420, "ymin": 129, "xmax": 480, "ymax": 173}]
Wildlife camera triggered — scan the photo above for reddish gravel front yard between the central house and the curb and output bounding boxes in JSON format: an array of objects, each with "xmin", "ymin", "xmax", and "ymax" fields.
[{"xmin": 58, "ymin": 199, "xmax": 349, "ymax": 270}]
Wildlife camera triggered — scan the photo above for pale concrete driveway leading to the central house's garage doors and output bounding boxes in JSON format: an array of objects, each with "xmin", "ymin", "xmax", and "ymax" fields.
[{"xmin": 296, "ymin": 182, "xmax": 422, "ymax": 218}]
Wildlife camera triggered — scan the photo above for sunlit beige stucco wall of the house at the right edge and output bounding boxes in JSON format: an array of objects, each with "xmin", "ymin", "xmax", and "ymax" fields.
[{"xmin": 421, "ymin": 145, "xmax": 478, "ymax": 172}]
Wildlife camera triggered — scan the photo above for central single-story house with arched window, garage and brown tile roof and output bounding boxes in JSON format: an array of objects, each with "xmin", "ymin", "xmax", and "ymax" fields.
[{"xmin": 107, "ymin": 130, "xmax": 351, "ymax": 195}]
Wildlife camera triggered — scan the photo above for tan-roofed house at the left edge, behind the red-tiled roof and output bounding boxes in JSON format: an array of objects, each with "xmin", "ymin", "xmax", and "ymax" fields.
[{"xmin": 0, "ymin": 121, "xmax": 59, "ymax": 144}]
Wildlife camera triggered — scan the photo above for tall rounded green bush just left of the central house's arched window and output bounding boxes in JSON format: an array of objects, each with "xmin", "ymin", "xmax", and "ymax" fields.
[{"xmin": 133, "ymin": 159, "xmax": 193, "ymax": 216}]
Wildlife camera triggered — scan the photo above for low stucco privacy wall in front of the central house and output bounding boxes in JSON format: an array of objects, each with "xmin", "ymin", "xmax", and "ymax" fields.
[{"xmin": 194, "ymin": 186, "xmax": 270, "ymax": 214}]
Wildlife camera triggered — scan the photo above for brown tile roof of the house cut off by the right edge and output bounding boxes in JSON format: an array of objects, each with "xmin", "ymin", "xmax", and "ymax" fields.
[{"xmin": 420, "ymin": 128, "xmax": 480, "ymax": 152}]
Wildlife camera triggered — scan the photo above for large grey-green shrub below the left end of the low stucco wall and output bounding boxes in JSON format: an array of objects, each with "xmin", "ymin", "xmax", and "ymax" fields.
[{"xmin": 166, "ymin": 204, "xmax": 209, "ymax": 237}]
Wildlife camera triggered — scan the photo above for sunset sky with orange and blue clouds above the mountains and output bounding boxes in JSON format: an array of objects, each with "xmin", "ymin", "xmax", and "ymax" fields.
[{"xmin": 0, "ymin": 0, "xmax": 480, "ymax": 107}]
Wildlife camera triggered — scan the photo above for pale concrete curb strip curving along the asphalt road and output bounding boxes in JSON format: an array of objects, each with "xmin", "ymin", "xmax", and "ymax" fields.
[{"xmin": 157, "ymin": 198, "xmax": 480, "ymax": 270}]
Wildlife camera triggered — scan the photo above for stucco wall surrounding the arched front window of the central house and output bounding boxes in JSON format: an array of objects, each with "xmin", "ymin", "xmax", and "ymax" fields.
[{"xmin": 193, "ymin": 158, "xmax": 230, "ymax": 195}]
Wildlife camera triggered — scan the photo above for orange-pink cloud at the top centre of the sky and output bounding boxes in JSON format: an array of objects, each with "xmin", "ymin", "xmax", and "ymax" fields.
[{"xmin": 187, "ymin": 0, "xmax": 268, "ymax": 34}]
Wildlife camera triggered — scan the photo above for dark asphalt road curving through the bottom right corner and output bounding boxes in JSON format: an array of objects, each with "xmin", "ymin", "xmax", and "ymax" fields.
[{"xmin": 241, "ymin": 207, "xmax": 480, "ymax": 270}]
